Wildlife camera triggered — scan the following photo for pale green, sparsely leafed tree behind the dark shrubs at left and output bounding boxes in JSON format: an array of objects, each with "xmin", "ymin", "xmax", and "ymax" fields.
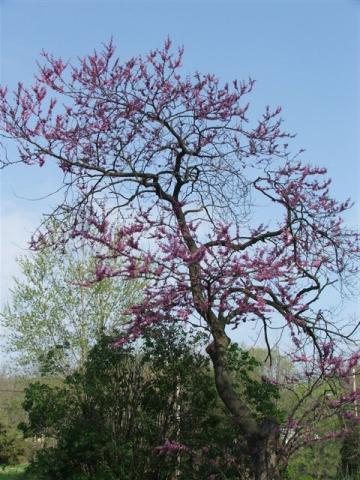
[{"xmin": 1, "ymin": 245, "xmax": 141, "ymax": 375}]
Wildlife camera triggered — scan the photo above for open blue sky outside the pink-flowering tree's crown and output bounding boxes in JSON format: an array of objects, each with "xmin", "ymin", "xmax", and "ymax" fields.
[{"xmin": 0, "ymin": 0, "xmax": 360, "ymax": 338}]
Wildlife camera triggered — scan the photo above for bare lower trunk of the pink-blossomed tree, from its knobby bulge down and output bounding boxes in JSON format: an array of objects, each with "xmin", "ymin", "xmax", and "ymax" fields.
[{"xmin": 206, "ymin": 331, "xmax": 281, "ymax": 480}]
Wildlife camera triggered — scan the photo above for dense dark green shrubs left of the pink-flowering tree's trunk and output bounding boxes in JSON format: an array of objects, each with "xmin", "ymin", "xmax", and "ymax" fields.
[{"xmin": 21, "ymin": 327, "xmax": 255, "ymax": 480}]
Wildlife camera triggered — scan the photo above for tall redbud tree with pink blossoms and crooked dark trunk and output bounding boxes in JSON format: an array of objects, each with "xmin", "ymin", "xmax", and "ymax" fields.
[{"xmin": 0, "ymin": 41, "xmax": 359, "ymax": 480}]
